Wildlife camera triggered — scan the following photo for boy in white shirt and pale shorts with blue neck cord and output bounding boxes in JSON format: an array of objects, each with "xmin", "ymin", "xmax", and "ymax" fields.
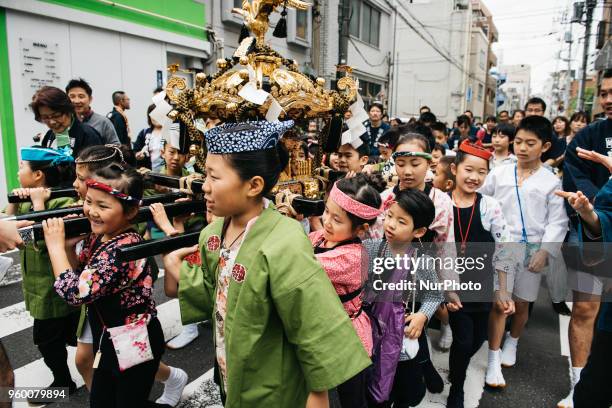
[{"xmin": 480, "ymin": 116, "xmax": 568, "ymax": 384}]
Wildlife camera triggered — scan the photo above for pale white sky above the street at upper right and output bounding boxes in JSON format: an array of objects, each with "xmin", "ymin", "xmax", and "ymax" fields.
[{"xmin": 484, "ymin": 0, "xmax": 603, "ymax": 94}]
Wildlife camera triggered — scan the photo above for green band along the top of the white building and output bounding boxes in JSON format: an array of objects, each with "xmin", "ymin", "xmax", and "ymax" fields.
[{"xmin": 39, "ymin": 0, "xmax": 208, "ymax": 40}]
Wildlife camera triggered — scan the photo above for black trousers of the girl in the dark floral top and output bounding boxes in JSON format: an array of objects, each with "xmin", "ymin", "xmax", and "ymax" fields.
[{"xmin": 89, "ymin": 318, "xmax": 164, "ymax": 408}]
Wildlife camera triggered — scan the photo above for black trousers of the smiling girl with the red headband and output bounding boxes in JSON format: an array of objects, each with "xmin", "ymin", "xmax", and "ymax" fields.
[{"xmin": 448, "ymin": 309, "xmax": 489, "ymax": 389}]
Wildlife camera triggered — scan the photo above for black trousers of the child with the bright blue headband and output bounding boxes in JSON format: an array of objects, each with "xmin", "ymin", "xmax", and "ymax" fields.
[{"xmin": 32, "ymin": 313, "xmax": 80, "ymax": 387}]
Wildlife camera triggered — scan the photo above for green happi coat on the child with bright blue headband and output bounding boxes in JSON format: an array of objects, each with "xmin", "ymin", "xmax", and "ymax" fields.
[{"xmin": 17, "ymin": 197, "xmax": 80, "ymax": 320}]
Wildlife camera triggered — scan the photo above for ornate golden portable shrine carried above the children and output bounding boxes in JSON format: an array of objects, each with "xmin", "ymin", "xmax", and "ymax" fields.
[{"xmin": 158, "ymin": 0, "xmax": 363, "ymax": 201}]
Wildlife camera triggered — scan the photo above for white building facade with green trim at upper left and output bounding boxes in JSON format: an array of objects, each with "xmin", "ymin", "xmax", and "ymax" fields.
[{"xmin": 0, "ymin": 0, "xmax": 211, "ymax": 205}]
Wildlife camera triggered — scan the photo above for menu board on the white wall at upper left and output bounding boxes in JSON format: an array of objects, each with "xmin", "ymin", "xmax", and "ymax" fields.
[{"xmin": 19, "ymin": 38, "xmax": 61, "ymax": 109}]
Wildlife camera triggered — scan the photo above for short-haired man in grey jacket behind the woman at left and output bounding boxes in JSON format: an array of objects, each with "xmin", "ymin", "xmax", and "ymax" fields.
[{"xmin": 66, "ymin": 78, "xmax": 119, "ymax": 144}]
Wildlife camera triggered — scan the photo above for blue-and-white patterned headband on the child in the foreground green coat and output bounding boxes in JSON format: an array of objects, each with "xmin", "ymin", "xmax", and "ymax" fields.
[{"xmin": 204, "ymin": 120, "xmax": 293, "ymax": 154}]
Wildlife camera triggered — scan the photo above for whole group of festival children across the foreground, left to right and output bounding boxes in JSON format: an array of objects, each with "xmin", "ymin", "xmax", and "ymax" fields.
[{"xmin": 2, "ymin": 107, "xmax": 596, "ymax": 408}]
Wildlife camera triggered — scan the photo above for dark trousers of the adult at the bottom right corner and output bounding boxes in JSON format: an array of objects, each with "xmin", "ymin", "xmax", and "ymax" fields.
[{"xmin": 574, "ymin": 330, "xmax": 612, "ymax": 408}]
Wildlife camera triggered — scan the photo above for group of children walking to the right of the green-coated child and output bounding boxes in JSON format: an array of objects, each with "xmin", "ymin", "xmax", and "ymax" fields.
[{"xmin": 292, "ymin": 112, "xmax": 568, "ymax": 407}]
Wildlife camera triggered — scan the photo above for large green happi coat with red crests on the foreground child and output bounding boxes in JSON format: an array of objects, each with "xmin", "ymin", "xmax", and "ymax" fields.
[{"xmin": 179, "ymin": 206, "xmax": 370, "ymax": 408}]
